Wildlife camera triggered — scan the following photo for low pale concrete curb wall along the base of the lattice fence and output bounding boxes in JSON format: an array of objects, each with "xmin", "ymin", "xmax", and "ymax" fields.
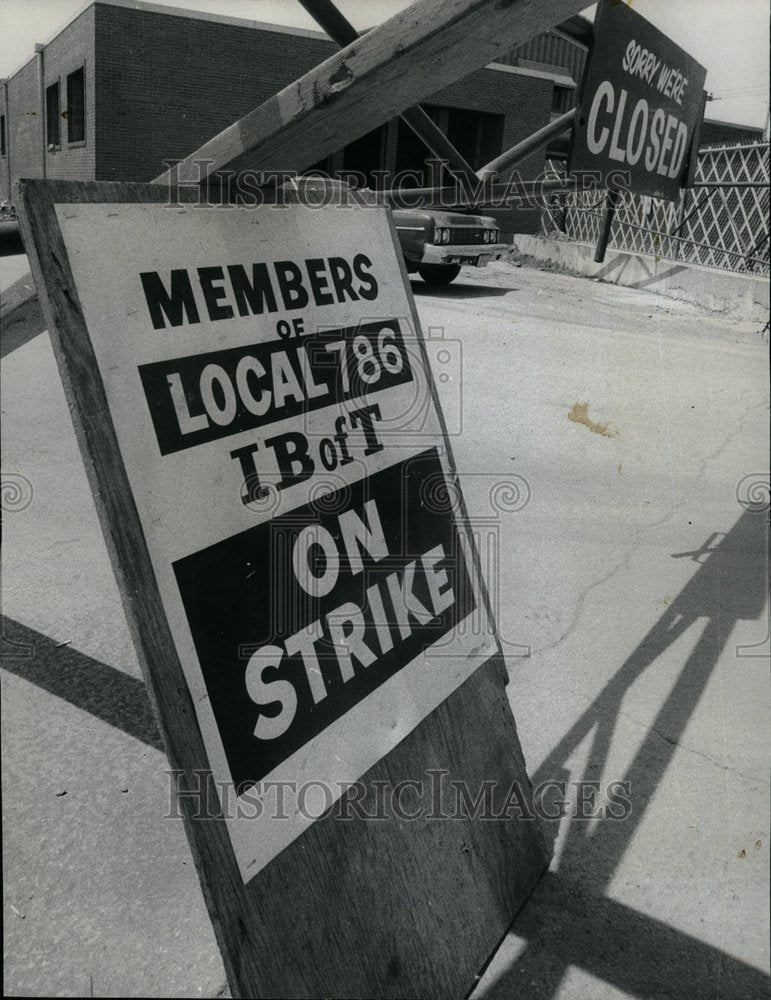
[{"xmin": 513, "ymin": 235, "xmax": 769, "ymax": 323}]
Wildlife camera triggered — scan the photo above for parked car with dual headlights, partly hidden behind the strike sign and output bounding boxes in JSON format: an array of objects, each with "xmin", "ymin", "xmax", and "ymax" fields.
[{"xmin": 393, "ymin": 208, "xmax": 509, "ymax": 285}]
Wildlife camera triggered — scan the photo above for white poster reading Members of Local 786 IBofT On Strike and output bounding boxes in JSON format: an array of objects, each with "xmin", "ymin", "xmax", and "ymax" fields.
[{"xmin": 56, "ymin": 203, "xmax": 497, "ymax": 882}]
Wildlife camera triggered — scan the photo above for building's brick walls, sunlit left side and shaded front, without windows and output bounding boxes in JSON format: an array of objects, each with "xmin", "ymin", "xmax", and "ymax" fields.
[{"xmin": 0, "ymin": 0, "xmax": 552, "ymax": 233}]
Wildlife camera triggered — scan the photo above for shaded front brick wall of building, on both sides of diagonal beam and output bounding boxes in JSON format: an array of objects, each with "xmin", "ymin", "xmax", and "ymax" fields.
[{"xmin": 95, "ymin": 3, "xmax": 552, "ymax": 232}]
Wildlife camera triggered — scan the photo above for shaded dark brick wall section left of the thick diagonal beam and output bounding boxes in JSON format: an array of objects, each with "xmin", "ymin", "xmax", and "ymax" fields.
[{"xmin": 96, "ymin": 3, "xmax": 336, "ymax": 181}]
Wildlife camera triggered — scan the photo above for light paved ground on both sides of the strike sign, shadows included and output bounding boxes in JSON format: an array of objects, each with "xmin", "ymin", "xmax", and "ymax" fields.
[{"xmin": 0, "ymin": 257, "xmax": 771, "ymax": 1000}]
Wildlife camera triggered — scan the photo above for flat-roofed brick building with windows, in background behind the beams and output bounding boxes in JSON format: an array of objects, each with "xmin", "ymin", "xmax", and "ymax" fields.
[{"xmin": 0, "ymin": 0, "xmax": 587, "ymax": 231}]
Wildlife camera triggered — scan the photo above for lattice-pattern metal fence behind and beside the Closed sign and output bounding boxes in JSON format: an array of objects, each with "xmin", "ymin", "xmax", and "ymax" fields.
[{"xmin": 541, "ymin": 142, "xmax": 769, "ymax": 275}]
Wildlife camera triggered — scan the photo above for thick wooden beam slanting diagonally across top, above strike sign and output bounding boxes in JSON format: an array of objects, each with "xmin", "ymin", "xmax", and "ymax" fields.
[{"xmin": 158, "ymin": 0, "xmax": 586, "ymax": 184}]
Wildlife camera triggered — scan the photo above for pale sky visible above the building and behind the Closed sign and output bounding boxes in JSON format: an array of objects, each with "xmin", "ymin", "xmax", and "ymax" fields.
[{"xmin": 0, "ymin": 0, "xmax": 770, "ymax": 126}]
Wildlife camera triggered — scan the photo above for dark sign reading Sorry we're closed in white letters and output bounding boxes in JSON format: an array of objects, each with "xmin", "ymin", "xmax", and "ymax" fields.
[{"xmin": 570, "ymin": 0, "xmax": 707, "ymax": 200}]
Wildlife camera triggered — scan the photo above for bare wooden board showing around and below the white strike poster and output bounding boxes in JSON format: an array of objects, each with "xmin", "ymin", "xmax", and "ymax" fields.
[{"xmin": 16, "ymin": 180, "xmax": 548, "ymax": 997}]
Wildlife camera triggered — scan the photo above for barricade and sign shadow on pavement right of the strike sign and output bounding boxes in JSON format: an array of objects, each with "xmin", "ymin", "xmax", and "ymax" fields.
[{"xmin": 479, "ymin": 510, "xmax": 771, "ymax": 1000}]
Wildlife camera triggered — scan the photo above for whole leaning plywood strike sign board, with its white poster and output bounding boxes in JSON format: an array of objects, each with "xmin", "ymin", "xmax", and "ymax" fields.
[{"xmin": 18, "ymin": 181, "xmax": 545, "ymax": 996}]
